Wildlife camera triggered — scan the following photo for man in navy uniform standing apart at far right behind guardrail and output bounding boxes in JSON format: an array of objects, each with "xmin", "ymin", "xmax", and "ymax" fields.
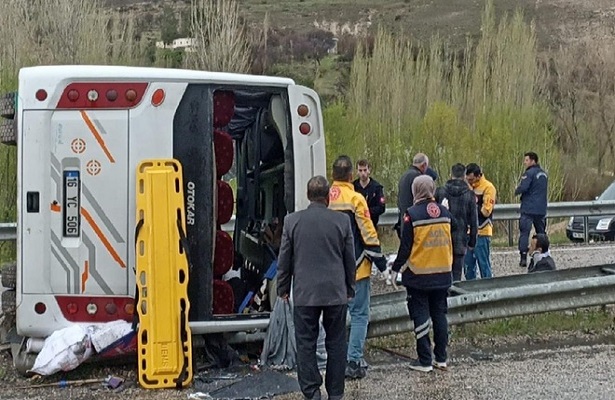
[{"xmin": 515, "ymin": 151, "xmax": 549, "ymax": 268}]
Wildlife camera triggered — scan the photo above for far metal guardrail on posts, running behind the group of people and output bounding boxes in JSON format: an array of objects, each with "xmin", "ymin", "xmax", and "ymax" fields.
[{"xmin": 0, "ymin": 200, "xmax": 615, "ymax": 241}]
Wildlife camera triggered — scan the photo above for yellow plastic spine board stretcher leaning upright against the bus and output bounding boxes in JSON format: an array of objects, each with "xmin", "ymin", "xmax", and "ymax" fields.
[{"xmin": 136, "ymin": 159, "xmax": 193, "ymax": 389}]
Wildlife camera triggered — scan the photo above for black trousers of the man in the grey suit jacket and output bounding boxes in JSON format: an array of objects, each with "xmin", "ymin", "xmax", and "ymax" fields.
[{"xmin": 294, "ymin": 304, "xmax": 348, "ymax": 399}]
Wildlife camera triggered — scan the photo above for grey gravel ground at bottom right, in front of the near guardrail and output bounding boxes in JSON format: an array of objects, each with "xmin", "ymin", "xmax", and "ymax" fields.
[{"xmin": 279, "ymin": 331, "xmax": 615, "ymax": 400}]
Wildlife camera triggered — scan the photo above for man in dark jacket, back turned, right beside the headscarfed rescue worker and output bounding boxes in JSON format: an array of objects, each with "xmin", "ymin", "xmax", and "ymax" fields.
[{"xmin": 436, "ymin": 164, "xmax": 478, "ymax": 282}]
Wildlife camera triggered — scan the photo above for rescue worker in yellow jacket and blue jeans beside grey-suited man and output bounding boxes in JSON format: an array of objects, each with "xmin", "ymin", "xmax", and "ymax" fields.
[{"xmin": 330, "ymin": 156, "xmax": 387, "ymax": 379}]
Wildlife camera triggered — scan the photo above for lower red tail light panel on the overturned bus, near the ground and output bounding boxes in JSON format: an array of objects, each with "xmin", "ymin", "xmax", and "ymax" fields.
[{"xmin": 56, "ymin": 296, "xmax": 134, "ymax": 322}]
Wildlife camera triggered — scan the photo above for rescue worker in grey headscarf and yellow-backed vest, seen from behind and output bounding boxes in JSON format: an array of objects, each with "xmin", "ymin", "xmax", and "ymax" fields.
[{"xmin": 392, "ymin": 175, "xmax": 453, "ymax": 372}]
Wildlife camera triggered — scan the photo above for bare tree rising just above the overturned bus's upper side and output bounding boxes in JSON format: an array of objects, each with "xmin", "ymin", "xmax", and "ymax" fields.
[{"xmin": 185, "ymin": 0, "xmax": 252, "ymax": 73}]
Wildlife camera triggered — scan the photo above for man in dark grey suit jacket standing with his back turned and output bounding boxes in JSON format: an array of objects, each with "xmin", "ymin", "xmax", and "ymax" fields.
[{"xmin": 278, "ymin": 176, "xmax": 356, "ymax": 400}]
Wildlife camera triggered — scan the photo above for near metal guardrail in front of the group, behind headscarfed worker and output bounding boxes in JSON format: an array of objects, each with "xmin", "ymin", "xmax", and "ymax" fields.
[{"xmin": 368, "ymin": 264, "xmax": 615, "ymax": 337}]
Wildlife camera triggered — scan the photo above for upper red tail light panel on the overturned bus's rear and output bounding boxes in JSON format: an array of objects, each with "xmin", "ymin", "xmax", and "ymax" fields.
[{"xmin": 56, "ymin": 82, "xmax": 148, "ymax": 110}]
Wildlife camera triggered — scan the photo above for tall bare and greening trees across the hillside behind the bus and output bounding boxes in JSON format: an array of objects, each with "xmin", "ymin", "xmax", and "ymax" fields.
[{"xmin": 0, "ymin": 0, "xmax": 615, "ymax": 256}]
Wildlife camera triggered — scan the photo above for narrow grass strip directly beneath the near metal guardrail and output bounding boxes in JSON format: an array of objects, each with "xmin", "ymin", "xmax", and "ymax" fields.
[{"xmin": 367, "ymin": 306, "xmax": 615, "ymax": 349}]
